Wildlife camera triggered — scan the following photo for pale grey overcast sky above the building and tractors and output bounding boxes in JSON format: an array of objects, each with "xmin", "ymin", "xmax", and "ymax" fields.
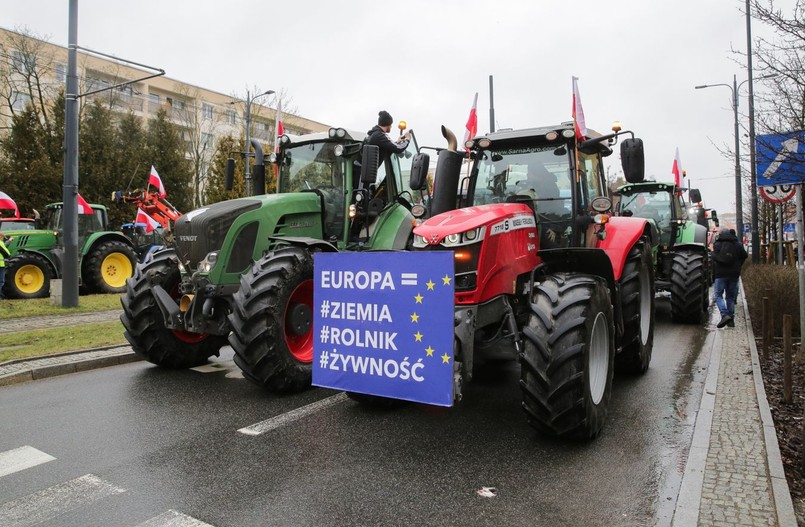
[{"xmin": 0, "ymin": 0, "xmax": 791, "ymax": 219}]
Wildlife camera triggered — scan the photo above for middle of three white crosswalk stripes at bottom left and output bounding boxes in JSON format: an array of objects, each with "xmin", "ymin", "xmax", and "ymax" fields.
[{"xmin": 0, "ymin": 474, "xmax": 126, "ymax": 527}]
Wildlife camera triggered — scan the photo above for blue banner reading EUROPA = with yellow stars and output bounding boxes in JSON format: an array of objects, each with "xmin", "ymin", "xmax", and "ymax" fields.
[{"xmin": 313, "ymin": 251, "xmax": 454, "ymax": 406}]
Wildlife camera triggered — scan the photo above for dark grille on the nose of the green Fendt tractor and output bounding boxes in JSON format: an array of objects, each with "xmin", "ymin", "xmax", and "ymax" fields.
[{"xmin": 173, "ymin": 200, "xmax": 260, "ymax": 269}]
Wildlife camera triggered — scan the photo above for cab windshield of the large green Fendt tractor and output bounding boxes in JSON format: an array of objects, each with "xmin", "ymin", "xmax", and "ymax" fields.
[{"xmin": 278, "ymin": 143, "xmax": 344, "ymax": 193}]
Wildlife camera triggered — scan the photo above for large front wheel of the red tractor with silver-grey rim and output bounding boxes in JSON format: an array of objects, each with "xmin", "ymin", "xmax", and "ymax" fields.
[{"xmin": 520, "ymin": 273, "xmax": 615, "ymax": 439}]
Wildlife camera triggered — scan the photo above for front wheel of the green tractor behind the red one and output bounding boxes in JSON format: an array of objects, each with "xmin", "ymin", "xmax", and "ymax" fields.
[{"xmin": 671, "ymin": 250, "xmax": 708, "ymax": 324}]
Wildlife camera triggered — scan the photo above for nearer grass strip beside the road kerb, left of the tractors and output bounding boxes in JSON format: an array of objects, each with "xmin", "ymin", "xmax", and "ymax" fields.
[{"xmin": 0, "ymin": 321, "xmax": 127, "ymax": 362}]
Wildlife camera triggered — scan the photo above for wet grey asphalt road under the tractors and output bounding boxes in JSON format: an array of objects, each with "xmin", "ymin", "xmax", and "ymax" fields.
[{"xmin": 0, "ymin": 298, "xmax": 709, "ymax": 527}]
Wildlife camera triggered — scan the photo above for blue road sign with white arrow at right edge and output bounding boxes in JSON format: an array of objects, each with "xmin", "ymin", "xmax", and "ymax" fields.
[{"xmin": 755, "ymin": 130, "xmax": 805, "ymax": 187}]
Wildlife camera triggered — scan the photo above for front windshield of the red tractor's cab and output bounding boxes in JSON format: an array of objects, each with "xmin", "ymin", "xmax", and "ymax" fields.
[{"xmin": 471, "ymin": 145, "xmax": 573, "ymax": 216}]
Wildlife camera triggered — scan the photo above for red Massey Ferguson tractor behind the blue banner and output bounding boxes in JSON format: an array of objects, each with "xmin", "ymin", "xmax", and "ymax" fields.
[{"xmin": 406, "ymin": 122, "xmax": 654, "ymax": 438}]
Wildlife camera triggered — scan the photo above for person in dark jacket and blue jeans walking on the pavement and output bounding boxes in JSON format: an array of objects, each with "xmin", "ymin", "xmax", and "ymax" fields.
[{"xmin": 713, "ymin": 227, "xmax": 748, "ymax": 328}]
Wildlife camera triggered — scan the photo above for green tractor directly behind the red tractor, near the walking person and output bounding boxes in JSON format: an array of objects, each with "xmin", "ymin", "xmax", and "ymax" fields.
[{"xmin": 618, "ymin": 181, "xmax": 711, "ymax": 324}]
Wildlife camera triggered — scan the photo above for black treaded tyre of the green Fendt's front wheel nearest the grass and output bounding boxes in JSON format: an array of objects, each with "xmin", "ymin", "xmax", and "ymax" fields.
[{"xmin": 120, "ymin": 249, "xmax": 226, "ymax": 368}]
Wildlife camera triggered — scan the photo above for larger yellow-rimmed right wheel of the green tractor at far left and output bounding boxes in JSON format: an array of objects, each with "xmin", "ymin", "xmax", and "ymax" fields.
[{"xmin": 83, "ymin": 240, "xmax": 137, "ymax": 293}]
